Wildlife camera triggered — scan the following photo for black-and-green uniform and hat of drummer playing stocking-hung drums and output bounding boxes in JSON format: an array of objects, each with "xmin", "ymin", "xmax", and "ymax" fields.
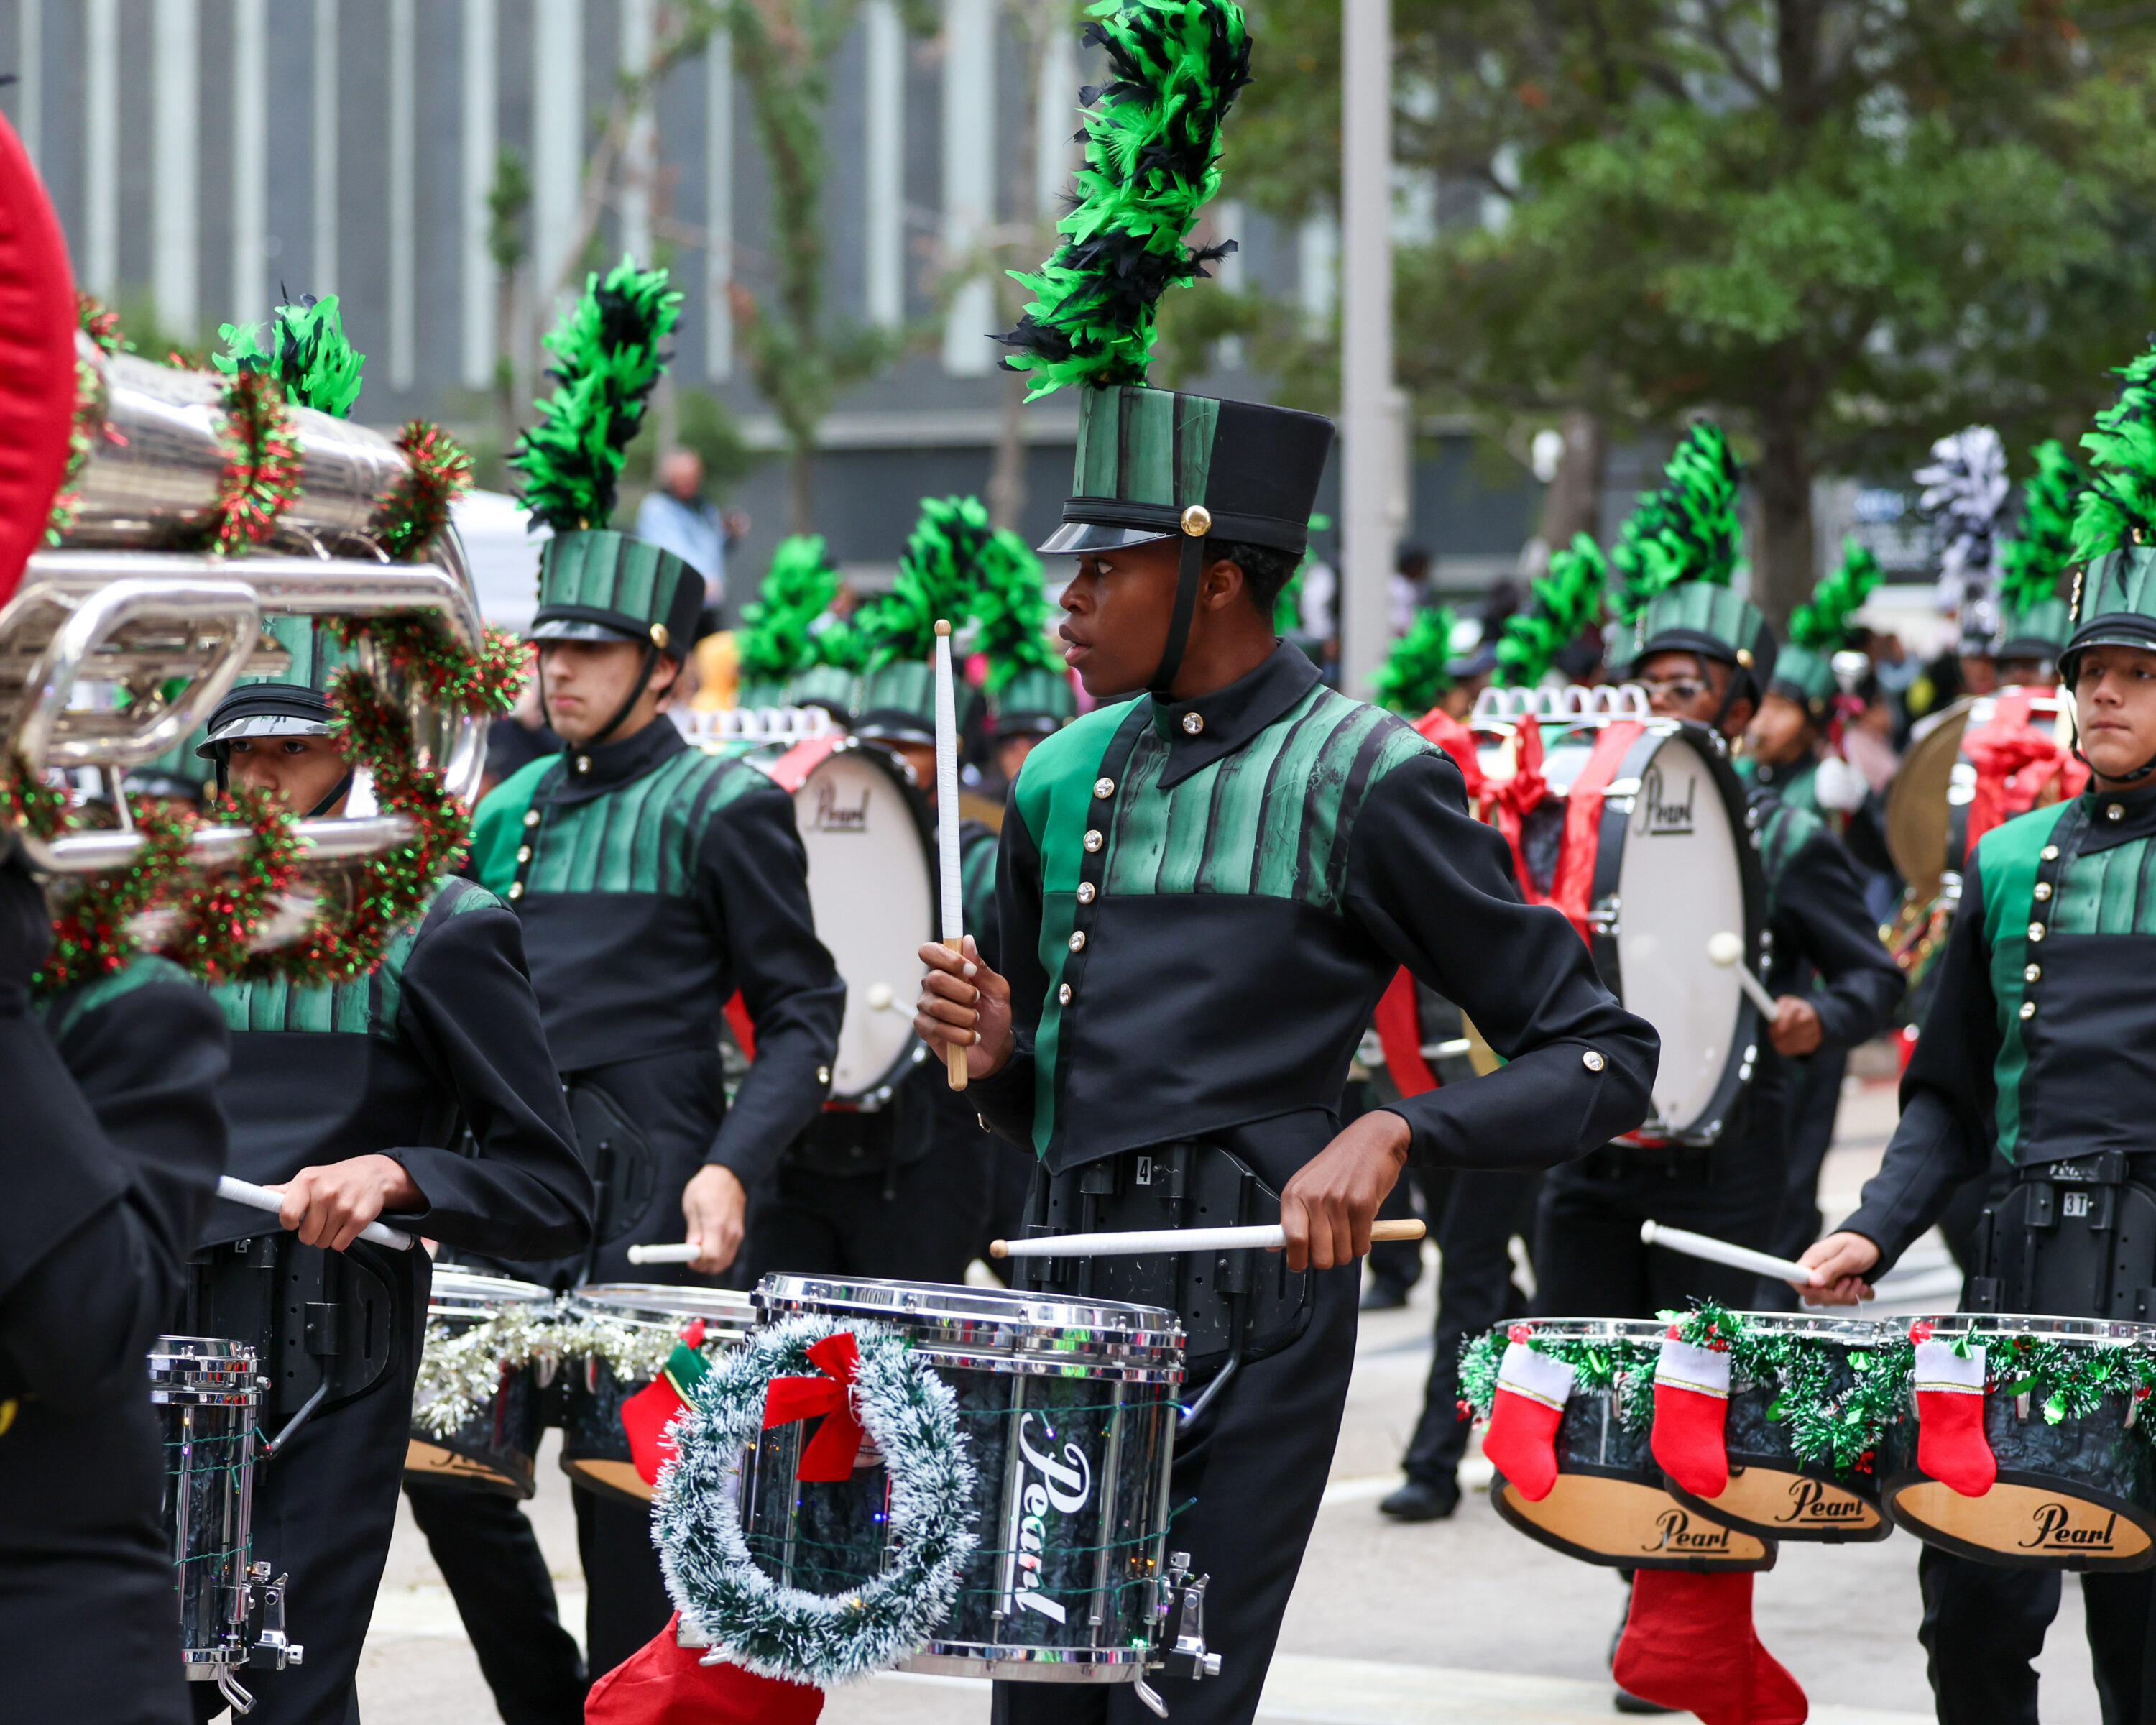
[{"xmin": 1841, "ymin": 550, "xmax": 2156, "ymax": 1725}]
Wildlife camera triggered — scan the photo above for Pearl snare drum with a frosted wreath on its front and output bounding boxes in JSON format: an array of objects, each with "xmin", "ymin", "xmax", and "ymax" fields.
[{"xmin": 742, "ymin": 1274, "xmax": 1184, "ymax": 1684}]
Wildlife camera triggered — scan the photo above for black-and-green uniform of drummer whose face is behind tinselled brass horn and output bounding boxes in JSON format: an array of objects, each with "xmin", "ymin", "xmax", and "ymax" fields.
[{"xmin": 177, "ymin": 668, "xmax": 593, "ymax": 1725}]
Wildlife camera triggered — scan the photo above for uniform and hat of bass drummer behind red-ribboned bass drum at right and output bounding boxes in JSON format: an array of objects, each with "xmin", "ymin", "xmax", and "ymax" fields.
[{"xmin": 1526, "ymin": 533, "xmax": 1902, "ymax": 1317}]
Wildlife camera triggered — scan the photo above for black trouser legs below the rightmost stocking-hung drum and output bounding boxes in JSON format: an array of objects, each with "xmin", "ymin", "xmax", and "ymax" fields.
[{"xmin": 1917, "ymin": 1546, "xmax": 2156, "ymax": 1725}]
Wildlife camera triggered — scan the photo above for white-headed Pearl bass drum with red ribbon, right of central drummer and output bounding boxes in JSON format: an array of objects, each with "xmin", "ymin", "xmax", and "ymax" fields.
[{"xmin": 1542, "ymin": 718, "xmax": 1766, "ymax": 1143}]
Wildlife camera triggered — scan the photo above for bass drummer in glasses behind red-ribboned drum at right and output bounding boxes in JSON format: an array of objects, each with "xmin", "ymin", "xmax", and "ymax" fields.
[{"xmin": 1526, "ymin": 425, "xmax": 1902, "ymax": 1317}]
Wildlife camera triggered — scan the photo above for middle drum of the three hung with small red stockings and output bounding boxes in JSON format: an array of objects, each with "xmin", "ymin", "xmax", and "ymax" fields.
[{"xmin": 1662, "ymin": 1311, "xmax": 1899, "ymax": 1544}]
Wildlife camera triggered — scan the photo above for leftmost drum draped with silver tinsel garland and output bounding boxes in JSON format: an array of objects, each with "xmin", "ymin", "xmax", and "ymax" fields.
[{"xmin": 405, "ymin": 1264, "xmax": 554, "ymax": 1496}]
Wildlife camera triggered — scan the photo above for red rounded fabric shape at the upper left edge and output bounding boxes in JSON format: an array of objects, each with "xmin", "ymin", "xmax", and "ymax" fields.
[{"xmin": 0, "ymin": 119, "xmax": 75, "ymax": 604}]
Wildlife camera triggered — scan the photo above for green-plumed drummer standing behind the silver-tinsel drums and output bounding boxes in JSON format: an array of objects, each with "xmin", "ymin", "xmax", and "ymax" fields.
[{"xmin": 472, "ymin": 263, "xmax": 845, "ymax": 1675}]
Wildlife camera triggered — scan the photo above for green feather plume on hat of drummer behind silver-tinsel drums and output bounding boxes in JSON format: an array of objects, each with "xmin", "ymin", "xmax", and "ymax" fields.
[{"xmin": 509, "ymin": 259, "xmax": 681, "ymax": 533}]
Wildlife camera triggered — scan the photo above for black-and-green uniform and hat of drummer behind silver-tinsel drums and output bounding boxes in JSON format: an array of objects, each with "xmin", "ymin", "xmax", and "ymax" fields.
[{"xmin": 459, "ymin": 530, "xmax": 845, "ymax": 1675}]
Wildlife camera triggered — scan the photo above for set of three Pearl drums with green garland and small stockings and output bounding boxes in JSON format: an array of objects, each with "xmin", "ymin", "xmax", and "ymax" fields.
[{"xmin": 1490, "ymin": 1313, "xmax": 2156, "ymax": 1572}]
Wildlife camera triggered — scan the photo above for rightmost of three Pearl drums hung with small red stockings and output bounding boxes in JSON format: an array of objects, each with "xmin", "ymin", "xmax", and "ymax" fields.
[{"xmin": 1884, "ymin": 1313, "xmax": 2156, "ymax": 1570}]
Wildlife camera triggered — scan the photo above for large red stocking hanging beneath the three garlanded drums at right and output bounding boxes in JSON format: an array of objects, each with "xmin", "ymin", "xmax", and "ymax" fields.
[{"xmin": 1611, "ymin": 1570, "xmax": 1809, "ymax": 1725}]
